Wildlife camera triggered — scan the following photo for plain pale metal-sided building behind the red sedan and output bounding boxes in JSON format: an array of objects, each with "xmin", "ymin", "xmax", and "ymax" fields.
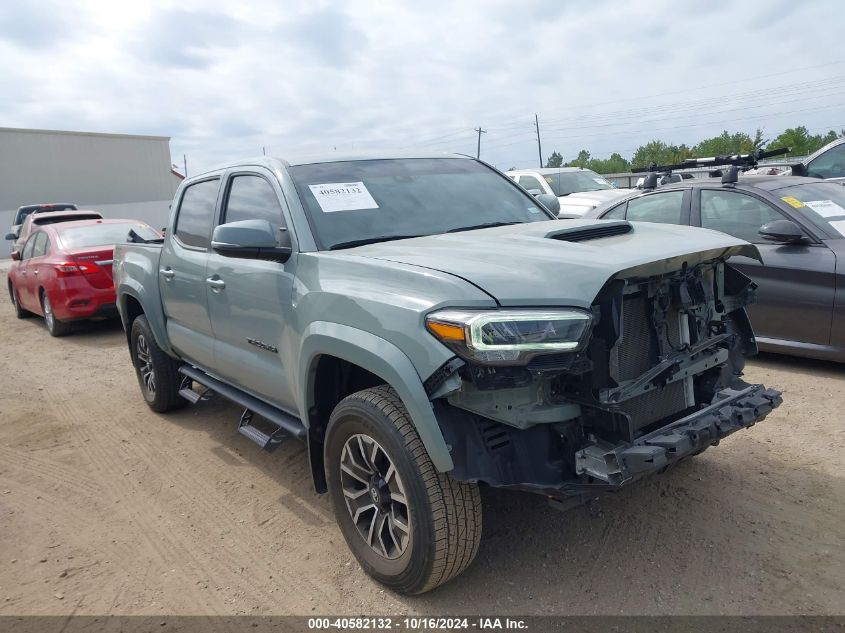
[{"xmin": 0, "ymin": 128, "xmax": 182, "ymax": 257}]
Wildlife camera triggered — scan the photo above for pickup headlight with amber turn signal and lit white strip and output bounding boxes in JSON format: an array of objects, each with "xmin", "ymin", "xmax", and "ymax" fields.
[{"xmin": 425, "ymin": 309, "xmax": 593, "ymax": 365}]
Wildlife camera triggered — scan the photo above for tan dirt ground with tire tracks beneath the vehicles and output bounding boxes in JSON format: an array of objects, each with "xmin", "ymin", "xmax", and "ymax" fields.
[{"xmin": 0, "ymin": 270, "xmax": 845, "ymax": 615}]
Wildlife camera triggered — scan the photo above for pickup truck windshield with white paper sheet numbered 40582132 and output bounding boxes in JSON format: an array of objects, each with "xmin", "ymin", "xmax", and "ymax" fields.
[{"xmin": 290, "ymin": 158, "xmax": 551, "ymax": 249}]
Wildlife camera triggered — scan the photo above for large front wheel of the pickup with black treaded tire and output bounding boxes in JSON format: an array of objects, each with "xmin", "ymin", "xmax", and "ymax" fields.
[{"xmin": 325, "ymin": 385, "xmax": 481, "ymax": 594}]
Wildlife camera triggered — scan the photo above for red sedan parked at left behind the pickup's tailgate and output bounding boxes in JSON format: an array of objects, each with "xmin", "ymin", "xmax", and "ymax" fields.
[{"xmin": 8, "ymin": 220, "xmax": 161, "ymax": 336}]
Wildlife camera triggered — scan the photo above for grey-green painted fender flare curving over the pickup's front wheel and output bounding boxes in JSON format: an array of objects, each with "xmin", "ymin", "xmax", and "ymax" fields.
[{"xmin": 297, "ymin": 321, "xmax": 454, "ymax": 472}]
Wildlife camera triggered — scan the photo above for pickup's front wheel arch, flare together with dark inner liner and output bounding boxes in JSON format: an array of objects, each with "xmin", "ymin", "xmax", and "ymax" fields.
[{"xmin": 298, "ymin": 321, "xmax": 454, "ymax": 492}]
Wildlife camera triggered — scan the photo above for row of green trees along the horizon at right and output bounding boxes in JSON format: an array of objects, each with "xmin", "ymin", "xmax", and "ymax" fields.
[{"xmin": 546, "ymin": 125, "xmax": 845, "ymax": 174}]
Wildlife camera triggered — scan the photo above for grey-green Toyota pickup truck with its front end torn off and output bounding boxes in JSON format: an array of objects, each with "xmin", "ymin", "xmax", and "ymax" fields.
[{"xmin": 114, "ymin": 154, "xmax": 781, "ymax": 593}]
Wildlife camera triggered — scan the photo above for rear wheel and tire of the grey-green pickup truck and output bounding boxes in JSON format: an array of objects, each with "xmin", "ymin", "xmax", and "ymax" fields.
[{"xmin": 129, "ymin": 315, "xmax": 187, "ymax": 413}]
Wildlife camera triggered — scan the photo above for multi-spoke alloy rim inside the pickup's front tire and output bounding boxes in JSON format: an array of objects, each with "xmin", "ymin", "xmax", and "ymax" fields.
[{"xmin": 340, "ymin": 433, "xmax": 411, "ymax": 559}]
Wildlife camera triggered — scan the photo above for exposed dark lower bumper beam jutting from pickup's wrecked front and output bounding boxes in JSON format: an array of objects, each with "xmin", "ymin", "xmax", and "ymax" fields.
[{"xmin": 572, "ymin": 385, "xmax": 783, "ymax": 486}]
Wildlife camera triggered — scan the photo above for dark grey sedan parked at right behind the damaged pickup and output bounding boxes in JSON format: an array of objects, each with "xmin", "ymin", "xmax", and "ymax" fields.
[{"xmin": 589, "ymin": 174, "xmax": 845, "ymax": 361}]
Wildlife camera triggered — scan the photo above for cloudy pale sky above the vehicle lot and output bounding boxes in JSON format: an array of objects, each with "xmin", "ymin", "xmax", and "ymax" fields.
[{"xmin": 0, "ymin": 0, "xmax": 845, "ymax": 173}]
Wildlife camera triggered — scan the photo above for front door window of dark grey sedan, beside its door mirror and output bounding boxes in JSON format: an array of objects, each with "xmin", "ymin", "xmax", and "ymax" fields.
[{"xmin": 701, "ymin": 189, "xmax": 784, "ymax": 243}]
